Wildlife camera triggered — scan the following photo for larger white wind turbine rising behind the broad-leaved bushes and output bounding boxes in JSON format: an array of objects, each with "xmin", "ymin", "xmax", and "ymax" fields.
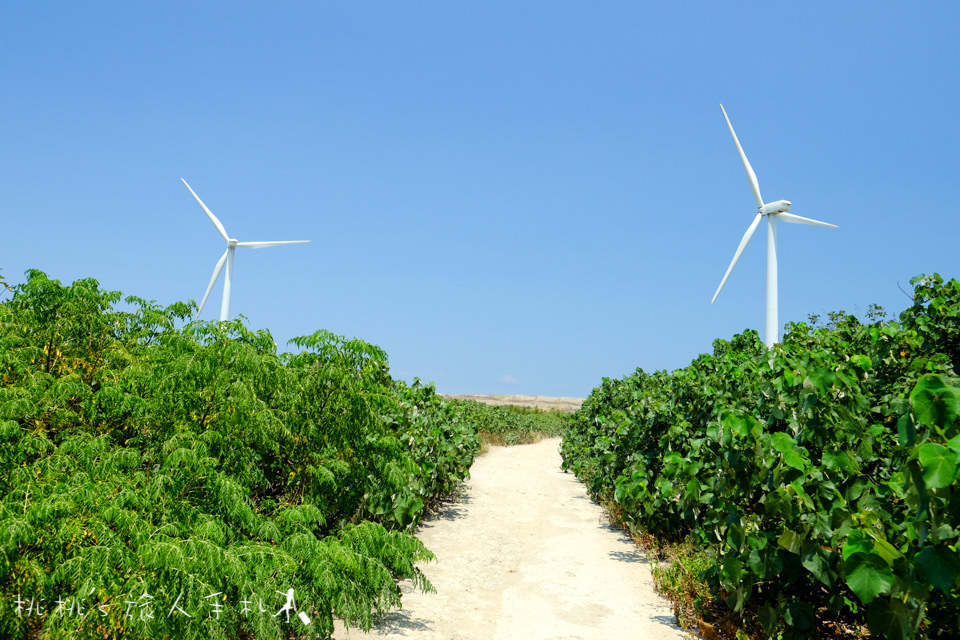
[{"xmin": 710, "ymin": 104, "xmax": 837, "ymax": 348}]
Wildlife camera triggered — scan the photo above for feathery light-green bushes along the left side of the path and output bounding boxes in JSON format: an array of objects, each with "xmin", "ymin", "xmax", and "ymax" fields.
[{"xmin": 0, "ymin": 271, "xmax": 480, "ymax": 639}]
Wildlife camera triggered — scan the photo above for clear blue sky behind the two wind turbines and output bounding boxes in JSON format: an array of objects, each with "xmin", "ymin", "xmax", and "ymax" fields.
[{"xmin": 0, "ymin": 0, "xmax": 960, "ymax": 396}]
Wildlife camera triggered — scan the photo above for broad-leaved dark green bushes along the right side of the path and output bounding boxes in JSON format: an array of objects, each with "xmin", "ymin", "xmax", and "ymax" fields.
[{"xmin": 562, "ymin": 275, "xmax": 960, "ymax": 638}]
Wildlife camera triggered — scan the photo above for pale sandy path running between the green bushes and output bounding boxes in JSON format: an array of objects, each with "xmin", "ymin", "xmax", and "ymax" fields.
[{"xmin": 334, "ymin": 438, "xmax": 688, "ymax": 640}]
